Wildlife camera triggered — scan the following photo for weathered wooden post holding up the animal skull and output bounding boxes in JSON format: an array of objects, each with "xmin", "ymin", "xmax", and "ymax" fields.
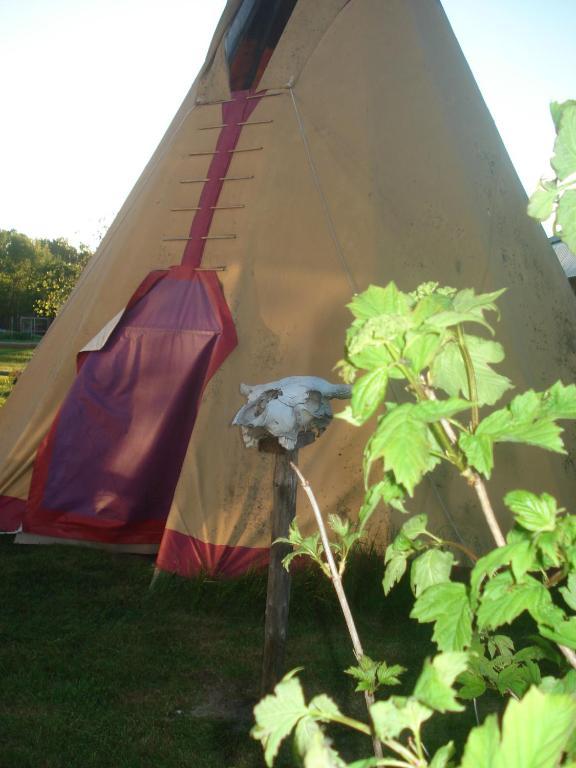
[{"xmin": 261, "ymin": 440, "xmax": 298, "ymax": 696}]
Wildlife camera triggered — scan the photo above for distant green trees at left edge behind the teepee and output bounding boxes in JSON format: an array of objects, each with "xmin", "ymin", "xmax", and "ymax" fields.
[{"xmin": 0, "ymin": 229, "xmax": 92, "ymax": 331}]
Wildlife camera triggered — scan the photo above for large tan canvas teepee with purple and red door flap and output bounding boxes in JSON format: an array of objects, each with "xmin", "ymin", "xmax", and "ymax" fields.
[{"xmin": 0, "ymin": 0, "xmax": 576, "ymax": 575}]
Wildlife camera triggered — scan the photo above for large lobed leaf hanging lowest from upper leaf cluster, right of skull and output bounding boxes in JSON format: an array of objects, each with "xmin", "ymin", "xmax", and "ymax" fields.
[{"xmin": 365, "ymin": 403, "xmax": 438, "ymax": 496}]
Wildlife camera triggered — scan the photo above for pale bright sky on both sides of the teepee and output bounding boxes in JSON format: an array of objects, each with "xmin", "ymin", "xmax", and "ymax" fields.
[{"xmin": 0, "ymin": 0, "xmax": 576, "ymax": 245}]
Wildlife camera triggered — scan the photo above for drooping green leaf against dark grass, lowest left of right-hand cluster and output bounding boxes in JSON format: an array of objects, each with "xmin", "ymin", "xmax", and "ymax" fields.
[{"xmin": 410, "ymin": 582, "xmax": 472, "ymax": 651}]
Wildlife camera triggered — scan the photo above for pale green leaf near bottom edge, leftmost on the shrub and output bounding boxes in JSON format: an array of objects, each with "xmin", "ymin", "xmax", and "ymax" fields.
[{"xmin": 250, "ymin": 670, "xmax": 308, "ymax": 766}]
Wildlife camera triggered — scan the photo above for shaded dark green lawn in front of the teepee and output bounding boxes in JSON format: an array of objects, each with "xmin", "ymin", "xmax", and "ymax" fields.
[{"xmin": 0, "ymin": 538, "xmax": 500, "ymax": 768}]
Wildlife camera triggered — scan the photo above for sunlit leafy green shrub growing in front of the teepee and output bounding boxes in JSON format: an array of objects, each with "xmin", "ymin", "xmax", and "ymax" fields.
[{"xmin": 253, "ymin": 283, "xmax": 576, "ymax": 768}]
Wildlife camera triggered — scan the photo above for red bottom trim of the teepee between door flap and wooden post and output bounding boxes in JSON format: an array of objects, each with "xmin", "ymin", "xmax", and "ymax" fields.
[{"xmin": 156, "ymin": 529, "xmax": 270, "ymax": 578}]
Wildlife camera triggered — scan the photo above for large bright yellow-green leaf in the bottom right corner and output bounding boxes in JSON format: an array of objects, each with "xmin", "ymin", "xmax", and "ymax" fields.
[{"xmin": 493, "ymin": 688, "xmax": 576, "ymax": 768}]
